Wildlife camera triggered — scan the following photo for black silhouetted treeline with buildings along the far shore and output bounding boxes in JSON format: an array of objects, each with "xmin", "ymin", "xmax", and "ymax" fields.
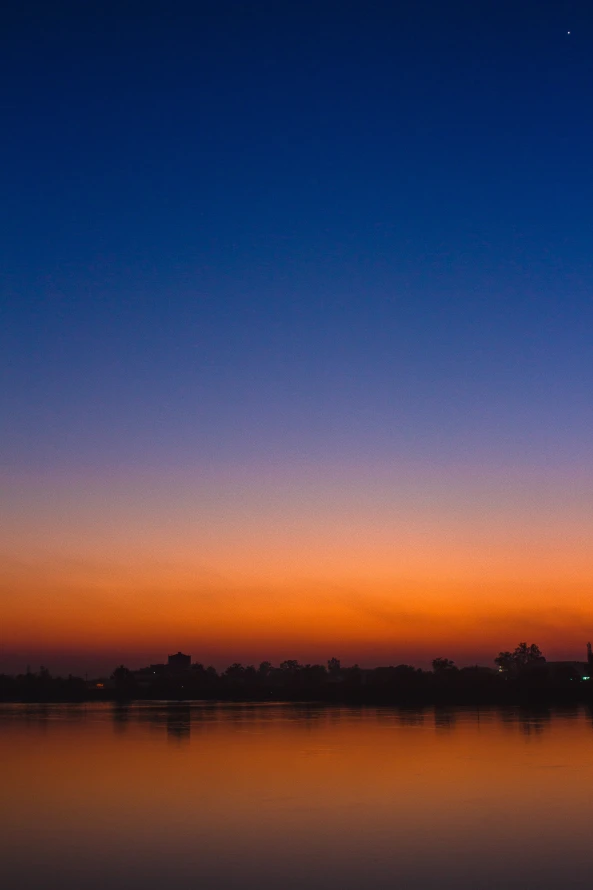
[{"xmin": 0, "ymin": 643, "xmax": 593, "ymax": 704}]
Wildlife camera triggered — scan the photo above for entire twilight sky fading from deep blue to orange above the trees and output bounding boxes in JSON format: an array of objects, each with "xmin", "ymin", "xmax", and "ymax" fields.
[{"xmin": 0, "ymin": 0, "xmax": 593, "ymax": 671}]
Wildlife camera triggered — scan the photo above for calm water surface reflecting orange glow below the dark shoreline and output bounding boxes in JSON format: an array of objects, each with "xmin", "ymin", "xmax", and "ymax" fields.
[{"xmin": 0, "ymin": 703, "xmax": 593, "ymax": 890}]
